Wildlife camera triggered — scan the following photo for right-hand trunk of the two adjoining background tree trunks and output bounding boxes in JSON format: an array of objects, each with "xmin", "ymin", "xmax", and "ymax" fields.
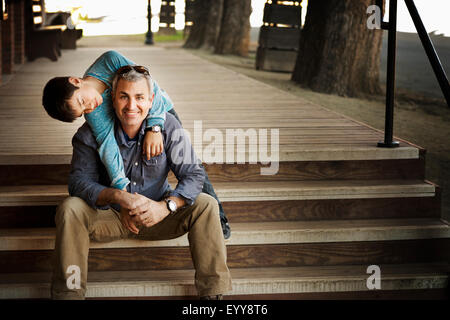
[{"xmin": 214, "ymin": 0, "xmax": 252, "ymax": 56}]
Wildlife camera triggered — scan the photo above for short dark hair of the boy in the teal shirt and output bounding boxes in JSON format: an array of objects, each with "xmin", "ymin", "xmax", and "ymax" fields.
[{"xmin": 42, "ymin": 77, "xmax": 78, "ymax": 122}]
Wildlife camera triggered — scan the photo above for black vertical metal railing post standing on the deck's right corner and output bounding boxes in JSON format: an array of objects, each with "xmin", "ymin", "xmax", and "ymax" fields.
[{"xmin": 378, "ymin": 0, "xmax": 399, "ymax": 148}]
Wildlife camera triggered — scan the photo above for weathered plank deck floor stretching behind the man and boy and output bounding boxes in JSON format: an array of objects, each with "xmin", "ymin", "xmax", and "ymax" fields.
[{"xmin": 0, "ymin": 47, "xmax": 419, "ymax": 164}]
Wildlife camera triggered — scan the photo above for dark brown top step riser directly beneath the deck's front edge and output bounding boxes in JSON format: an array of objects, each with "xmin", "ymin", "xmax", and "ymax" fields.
[{"xmin": 0, "ymin": 156, "xmax": 425, "ymax": 186}]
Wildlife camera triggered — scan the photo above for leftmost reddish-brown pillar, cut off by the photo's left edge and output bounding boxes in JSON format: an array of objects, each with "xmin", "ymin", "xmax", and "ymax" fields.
[{"xmin": 2, "ymin": 2, "xmax": 14, "ymax": 74}]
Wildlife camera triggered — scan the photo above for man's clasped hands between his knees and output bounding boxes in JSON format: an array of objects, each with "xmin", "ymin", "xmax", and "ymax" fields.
[{"xmin": 130, "ymin": 199, "xmax": 170, "ymax": 228}]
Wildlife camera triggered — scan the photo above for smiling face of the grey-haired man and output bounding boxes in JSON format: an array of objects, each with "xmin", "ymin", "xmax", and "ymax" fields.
[{"xmin": 113, "ymin": 79, "xmax": 153, "ymax": 129}]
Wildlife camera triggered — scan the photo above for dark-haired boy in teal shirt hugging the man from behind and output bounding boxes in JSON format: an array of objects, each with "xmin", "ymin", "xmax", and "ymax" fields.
[{"xmin": 42, "ymin": 50, "xmax": 231, "ymax": 239}]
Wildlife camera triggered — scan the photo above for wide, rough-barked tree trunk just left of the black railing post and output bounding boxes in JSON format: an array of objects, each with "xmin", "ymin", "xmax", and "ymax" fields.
[{"xmin": 292, "ymin": 0, "xmax": 383, "ymax": 96}]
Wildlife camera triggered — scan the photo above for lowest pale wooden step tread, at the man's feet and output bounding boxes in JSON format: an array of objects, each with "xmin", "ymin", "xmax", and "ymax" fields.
[{"xmin": 0, "ymin": 264, "xmax": 449, "ymax": 299}]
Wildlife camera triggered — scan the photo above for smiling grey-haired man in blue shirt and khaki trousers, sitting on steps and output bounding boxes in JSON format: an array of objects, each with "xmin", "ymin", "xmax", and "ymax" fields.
[{"xmin": 51, "ymin": 66, "xmax": 231, "ymax": 299}]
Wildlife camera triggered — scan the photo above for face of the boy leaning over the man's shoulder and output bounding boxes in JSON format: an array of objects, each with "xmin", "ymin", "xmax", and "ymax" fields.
[{"xmin": 68, "ymin": 78, "xmax": 103, "ymax": 117}]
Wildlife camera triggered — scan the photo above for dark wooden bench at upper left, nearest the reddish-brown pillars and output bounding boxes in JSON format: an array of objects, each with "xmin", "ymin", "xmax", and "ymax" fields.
[{"xmin": 25, "ymin": 0, "xmax": 62, "ymax": 61}]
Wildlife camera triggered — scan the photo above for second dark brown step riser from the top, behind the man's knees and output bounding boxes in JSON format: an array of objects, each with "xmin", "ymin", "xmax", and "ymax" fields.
[{"xmin": 0, "ymin": 186, "xmax": 441, "ymax": 229}]
